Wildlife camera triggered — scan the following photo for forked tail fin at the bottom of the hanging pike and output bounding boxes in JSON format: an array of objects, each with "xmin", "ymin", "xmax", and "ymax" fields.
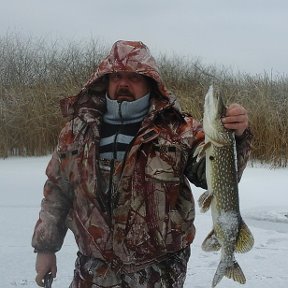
[{"xmin": 212, "ymin": 260, "xmax": 246, "ymax": 287}]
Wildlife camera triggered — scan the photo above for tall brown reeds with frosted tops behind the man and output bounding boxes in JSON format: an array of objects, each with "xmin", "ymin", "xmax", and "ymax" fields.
[{"xmin": 0, "ymin": 34, "xmax": 288, "ymax": 167}]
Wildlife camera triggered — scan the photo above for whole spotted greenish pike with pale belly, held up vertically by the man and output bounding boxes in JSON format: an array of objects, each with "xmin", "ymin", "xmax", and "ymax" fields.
[{"xmin": 198, "ymin": 86, "xmax": 254, "ymax": 287}]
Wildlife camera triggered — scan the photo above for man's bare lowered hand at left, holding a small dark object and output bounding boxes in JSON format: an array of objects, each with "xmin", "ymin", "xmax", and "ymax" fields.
[{"xmin": 35, "ymin": 252, "xmax": 57, "ymax": 287}]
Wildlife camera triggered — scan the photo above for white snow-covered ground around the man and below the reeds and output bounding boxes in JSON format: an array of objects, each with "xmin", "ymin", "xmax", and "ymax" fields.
[{"xmin": 0, "ymin": 157, "xmax": 288, "ymax": 288}]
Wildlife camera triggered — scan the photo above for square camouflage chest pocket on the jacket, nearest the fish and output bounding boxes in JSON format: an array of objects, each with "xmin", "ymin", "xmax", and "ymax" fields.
[{"xmin": 145, "ymin": 144, "xmax": 181, "ymax": 182}]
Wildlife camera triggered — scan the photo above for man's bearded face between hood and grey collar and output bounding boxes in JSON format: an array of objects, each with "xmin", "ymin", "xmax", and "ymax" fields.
[{"xmin": 108, "ymin": 72, "xmax": 150, "ymax": 101}]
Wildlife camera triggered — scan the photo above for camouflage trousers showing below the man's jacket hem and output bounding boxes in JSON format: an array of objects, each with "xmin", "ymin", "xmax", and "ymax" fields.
[{"xmin": 70, "ymin": 247, "xmax": 190, "ymax": 288}]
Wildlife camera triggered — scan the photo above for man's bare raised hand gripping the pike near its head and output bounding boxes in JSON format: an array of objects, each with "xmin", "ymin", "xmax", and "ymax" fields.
[{"xmin": 222, "ymin": 103, "xmax": 248, "ymax": 137}]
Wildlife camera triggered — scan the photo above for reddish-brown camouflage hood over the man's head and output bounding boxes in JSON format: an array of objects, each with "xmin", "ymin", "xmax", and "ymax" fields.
[{"xmin": 60, "ymin": 40, "xmax": 175, "ymax": 116}]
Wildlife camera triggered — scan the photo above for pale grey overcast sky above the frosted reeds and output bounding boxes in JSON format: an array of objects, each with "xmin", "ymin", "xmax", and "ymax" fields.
[{"xmin": 0, "ymin": 0, "xmax": 288, "ymax": 74}]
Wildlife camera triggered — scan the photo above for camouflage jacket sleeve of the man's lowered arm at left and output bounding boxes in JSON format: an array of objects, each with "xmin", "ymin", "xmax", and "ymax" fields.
[{"xmin": 32, "ymin": 151, "xmax": 72, "ymax": 252}]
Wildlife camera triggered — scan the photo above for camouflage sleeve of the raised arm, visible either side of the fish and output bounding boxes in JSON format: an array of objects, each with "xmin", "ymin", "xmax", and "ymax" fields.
[{"xmin": 185, "ymin": 128, "xmax": 253, "ymax": 189}]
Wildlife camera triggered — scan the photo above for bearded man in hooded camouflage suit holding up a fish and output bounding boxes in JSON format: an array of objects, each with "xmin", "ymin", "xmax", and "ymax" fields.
[{"xmin": 32, "ymin": 41, "xmax": 251, "ymax": 288}]
